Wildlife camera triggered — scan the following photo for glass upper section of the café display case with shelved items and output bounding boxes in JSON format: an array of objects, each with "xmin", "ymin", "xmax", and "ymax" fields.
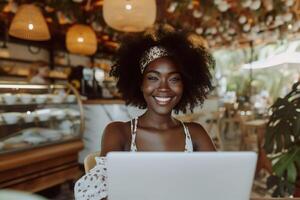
[{"xmin": 0, "ymin": 82, "xmax": 84, "ymax": 155}]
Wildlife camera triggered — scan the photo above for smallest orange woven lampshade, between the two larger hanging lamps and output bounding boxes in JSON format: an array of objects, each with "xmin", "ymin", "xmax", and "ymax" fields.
[{"xmin": 66, "ymin": 24, "xmax": 97, "ymax": 55}]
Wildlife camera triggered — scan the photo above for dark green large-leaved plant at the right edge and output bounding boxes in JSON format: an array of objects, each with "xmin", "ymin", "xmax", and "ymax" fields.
[{"xmin": 264, "ymin": 82, "xmax": 300, "ymax": 197}]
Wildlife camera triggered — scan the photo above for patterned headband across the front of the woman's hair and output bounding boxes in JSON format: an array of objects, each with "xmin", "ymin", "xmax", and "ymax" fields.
[{"xmin": 140, "ymin": 46, "xmax": 170, "ymax": 74}]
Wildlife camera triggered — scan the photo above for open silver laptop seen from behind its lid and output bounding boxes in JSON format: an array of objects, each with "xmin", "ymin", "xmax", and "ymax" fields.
[{"xmin": 107, "ymin": 152, "xmax": 257, "ymax": 200}]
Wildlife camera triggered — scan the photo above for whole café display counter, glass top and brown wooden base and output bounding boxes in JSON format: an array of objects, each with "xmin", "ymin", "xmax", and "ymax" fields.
[{"xmin": 0, "ymin": 82, "xmax": 84, "ymax": 192}]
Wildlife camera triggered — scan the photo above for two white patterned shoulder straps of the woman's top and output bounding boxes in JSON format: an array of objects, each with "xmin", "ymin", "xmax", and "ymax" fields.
[{"xmin": 130, "ymin": 117, "xmax": 193, "ymax": 152}]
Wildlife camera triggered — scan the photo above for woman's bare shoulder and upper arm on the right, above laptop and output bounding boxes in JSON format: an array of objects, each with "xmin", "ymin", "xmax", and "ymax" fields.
[{"xmin": 185, "ymin": 122, "xmax": 215, "ymax": 151}]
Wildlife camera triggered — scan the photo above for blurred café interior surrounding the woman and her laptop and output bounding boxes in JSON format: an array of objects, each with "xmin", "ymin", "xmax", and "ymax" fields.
[{"xmin": 0, "ymin": 0, "xmax": 300, "ymax": 199}]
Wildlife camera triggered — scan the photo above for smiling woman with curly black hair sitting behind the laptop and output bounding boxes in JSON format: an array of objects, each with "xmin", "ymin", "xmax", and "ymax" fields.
[{"xmin": 75, "ymin": 30, "xmax": 215, "ymax": 199}]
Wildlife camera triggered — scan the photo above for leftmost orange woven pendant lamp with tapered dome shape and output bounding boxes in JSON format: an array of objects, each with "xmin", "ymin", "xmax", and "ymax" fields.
[{"xmin": 8, "ymin": 4, "xmax": 50, "ymax": 41}]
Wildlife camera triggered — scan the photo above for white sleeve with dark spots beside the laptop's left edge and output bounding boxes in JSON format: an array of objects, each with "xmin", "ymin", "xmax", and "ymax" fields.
[{"xmin": 74, "ymin": 157, "xmax": 107, "ymax": 200}]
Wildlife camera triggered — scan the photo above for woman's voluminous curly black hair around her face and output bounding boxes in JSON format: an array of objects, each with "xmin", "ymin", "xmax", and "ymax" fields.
[{"xmin": 110, "ymin": 32, "xmax": 215, "ymax": 113}]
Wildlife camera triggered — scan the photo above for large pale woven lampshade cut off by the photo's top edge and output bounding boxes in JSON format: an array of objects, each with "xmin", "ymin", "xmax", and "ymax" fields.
[{"xmin": 103, "ymin": 0, "xmax": 156, "ymax": 32}]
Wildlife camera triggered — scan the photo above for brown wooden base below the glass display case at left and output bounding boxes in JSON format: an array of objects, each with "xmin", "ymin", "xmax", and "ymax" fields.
[{"xmin": 0, "ymin": 139, "xmax": 83, "ymax": 192}]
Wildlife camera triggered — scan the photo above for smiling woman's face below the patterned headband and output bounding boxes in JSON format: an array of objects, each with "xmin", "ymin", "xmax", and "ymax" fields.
[{"xmin": 141, "ymin": 58, "xmax": 183, "ymax": 114}]
